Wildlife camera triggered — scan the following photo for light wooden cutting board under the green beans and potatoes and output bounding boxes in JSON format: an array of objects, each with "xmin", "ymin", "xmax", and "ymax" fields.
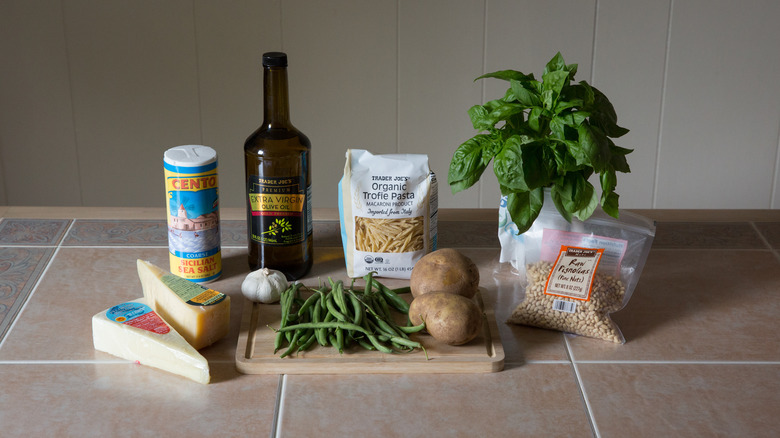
[{"xmin": 236, "ymin": 291, "xmax": 504, "ymax": 374}]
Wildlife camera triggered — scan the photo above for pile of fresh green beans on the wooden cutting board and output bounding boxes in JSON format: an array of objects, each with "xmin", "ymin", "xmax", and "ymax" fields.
[{"xmin": 274, "ymin": 274, "xmax": 427, "ymax": 358}]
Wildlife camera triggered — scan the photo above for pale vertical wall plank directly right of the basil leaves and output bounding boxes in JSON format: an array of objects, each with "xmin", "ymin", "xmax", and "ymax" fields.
[{"xmin": 592, "ymin": 0, "xmax": 670, "ymax": 208}]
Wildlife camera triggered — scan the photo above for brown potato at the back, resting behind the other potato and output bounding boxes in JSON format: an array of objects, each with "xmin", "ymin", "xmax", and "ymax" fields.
[{"xmin": 409, "ymin": 248, "xmax": 479, "ymax": 298}]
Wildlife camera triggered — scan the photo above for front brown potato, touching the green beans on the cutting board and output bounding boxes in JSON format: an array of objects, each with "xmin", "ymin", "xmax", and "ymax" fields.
[{"xmin": 409, "ymin": 292, "xmax": 482, "ymax": 345}]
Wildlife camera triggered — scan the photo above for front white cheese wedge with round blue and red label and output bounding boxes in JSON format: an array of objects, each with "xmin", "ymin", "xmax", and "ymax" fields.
[{"xmin": 92, "ymin": 298, "xmax": 211, "ymax": 384}]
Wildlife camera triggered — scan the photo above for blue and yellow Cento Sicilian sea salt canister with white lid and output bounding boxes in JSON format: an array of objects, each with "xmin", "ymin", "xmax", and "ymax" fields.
[{"xmin": 164, "ymin": 145, "xmax": 222, "ymax": 283}]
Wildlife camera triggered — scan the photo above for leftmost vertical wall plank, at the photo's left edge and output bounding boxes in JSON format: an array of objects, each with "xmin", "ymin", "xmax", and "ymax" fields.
[{"xmin": 0, "ymin": 1, "xmax": 81, "ymax": 206}]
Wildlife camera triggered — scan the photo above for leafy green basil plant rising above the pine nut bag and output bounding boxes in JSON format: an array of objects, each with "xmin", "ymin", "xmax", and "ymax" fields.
[{"xmin": 447, "ymin": 53, "xmax": 632, "ymax": 233}]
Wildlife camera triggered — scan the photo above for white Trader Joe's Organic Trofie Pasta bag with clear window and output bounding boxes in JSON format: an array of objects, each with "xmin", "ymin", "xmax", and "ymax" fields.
[{"xmin": 338, "ymin": 149, "xmax": 438, "ymax": 279}]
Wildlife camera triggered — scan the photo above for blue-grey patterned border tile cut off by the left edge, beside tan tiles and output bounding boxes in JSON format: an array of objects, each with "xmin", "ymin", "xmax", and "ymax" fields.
[{"xmin": 0, "ymin": 247, "xmax": 54, "ymax": 341}]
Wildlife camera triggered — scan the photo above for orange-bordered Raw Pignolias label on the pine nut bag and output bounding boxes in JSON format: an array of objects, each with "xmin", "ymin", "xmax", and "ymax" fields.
[{"xmin": 544, "ymin": 245, "xmax": 604, "ymax": 301}]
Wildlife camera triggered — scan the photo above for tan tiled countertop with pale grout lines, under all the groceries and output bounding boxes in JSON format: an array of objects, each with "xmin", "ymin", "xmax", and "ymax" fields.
[{"xmin": 0, "ymin": 206, "xmax": 780, "ymax": 437}]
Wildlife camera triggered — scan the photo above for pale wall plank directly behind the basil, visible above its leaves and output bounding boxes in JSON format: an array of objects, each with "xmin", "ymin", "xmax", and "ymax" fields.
[{"xmin": 478, "ymin": 0, "xmax": 596, "ymax": 208}]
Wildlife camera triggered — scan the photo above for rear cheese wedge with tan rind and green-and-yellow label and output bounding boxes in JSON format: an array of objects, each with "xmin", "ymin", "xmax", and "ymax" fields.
[{"xmin": 137, "ymin": 260, "xmax": 230, "ymax": 350}]
